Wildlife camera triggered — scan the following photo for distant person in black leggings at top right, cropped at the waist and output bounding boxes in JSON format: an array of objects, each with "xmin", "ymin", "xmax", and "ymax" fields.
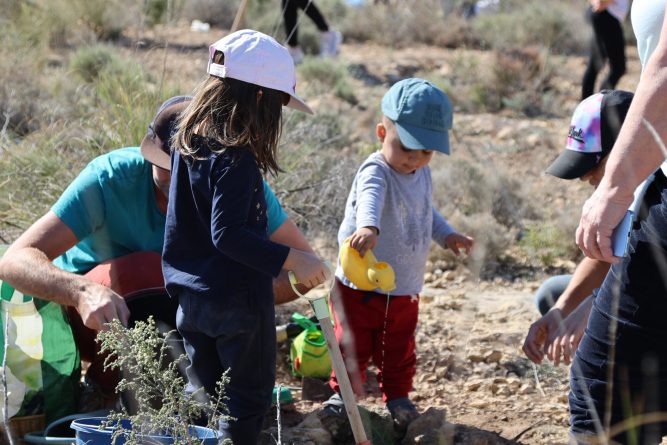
[{"xmin": 581, "ymin": 0, "xmax": 629, "ymax": 100}]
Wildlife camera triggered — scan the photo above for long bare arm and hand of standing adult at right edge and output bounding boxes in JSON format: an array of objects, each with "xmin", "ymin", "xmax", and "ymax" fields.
[{"xmin": 576, "ymin": 8, "xmax": 667, "ymax": 262}]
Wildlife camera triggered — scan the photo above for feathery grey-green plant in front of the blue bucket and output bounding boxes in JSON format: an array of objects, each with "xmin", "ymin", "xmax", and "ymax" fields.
[{"xmin": 97, "ymin": 318, "xmax": 231, "ymax": 445}]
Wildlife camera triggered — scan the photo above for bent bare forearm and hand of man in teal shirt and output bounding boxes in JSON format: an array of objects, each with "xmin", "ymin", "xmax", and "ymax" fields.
[{"xmin": 0, "ymin": 211, "xmax": 129, "ymax": 330}]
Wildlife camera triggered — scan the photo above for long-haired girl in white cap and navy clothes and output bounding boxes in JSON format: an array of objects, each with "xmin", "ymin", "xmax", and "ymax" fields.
[{"xmin": 162, "ymin": 30, "xmax": 327, "ymax": 445}]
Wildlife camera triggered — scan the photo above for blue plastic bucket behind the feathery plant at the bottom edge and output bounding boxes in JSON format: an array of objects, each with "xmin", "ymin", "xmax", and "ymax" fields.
[{"xmin": 70, "ymin": 417, "xmax": 218, "ymax": 445}]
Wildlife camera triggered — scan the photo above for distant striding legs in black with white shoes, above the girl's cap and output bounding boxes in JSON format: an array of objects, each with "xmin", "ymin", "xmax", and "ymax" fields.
[{"xmin": 282, "ymin": 0, "xmax": 343, "ymax": 63}]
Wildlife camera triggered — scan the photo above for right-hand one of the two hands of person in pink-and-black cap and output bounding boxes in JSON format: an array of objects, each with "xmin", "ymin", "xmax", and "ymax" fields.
[{"xmin": 545, "ymin": 295, "xmax": 593, "ymax": 366}]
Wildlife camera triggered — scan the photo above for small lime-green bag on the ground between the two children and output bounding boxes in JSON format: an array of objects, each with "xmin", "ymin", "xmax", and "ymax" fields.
[{"xmin": 290, "ymin": 313, "xmax": 331, "ymax": 378}]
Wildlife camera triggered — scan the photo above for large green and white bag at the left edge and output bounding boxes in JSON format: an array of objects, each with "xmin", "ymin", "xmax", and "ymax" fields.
[{"xmin": 0, "ymin": 281, "xmax": 81, "ymax": 424}]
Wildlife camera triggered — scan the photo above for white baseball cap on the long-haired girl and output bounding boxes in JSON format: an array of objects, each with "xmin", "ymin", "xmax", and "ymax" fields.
[{"xmin": 207, "ymin": 29, "xmax": 313, "ymax": 114}]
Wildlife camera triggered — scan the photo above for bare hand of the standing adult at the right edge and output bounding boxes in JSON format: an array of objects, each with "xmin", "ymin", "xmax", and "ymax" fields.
[{"xmin": 576, "ymin": 180, "xmax": 632, "ymax": 263}]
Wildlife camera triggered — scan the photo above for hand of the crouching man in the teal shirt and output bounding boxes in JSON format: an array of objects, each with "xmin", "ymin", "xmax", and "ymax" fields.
[{"xmin": 74, "ymin": 281, "xmax": 130, "ymax": 331}]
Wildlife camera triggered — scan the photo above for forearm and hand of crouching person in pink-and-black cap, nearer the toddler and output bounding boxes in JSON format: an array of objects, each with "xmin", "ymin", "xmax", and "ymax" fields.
[{"xmin": 523, "ymin": 258, "xmax": 610, "ymax": 366}]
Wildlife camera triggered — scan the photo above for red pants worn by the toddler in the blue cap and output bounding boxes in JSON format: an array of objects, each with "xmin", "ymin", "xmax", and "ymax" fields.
[{"xmin": 329, "ymin": 280, "xmax": 419, "ymax": 402}]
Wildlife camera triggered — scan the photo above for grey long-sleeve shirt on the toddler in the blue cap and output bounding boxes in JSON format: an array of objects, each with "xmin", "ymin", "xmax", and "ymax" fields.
[{"xmin": 336, "ymin": 152, "xmax": 455, "ymax": 295}]
